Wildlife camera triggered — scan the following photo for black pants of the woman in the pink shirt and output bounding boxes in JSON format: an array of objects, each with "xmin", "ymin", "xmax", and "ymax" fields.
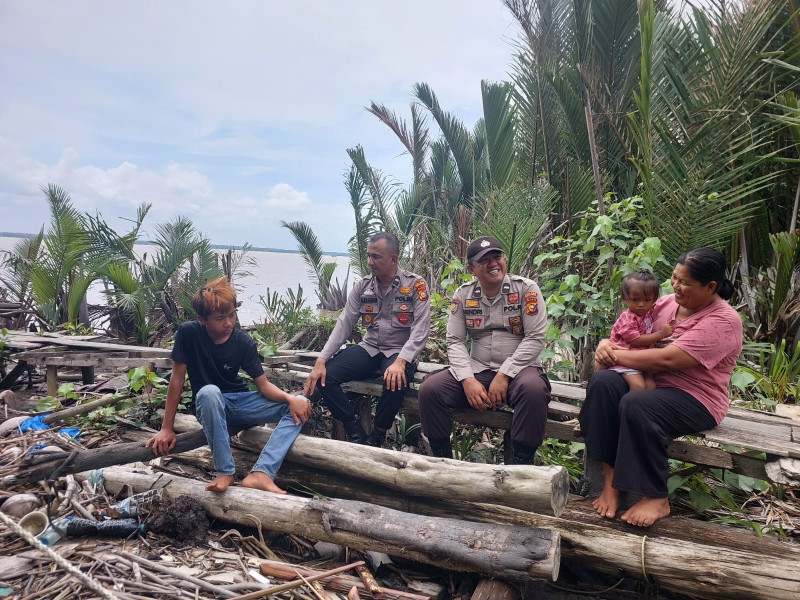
[{"xmin": 578, "ymin": 369, "xmax": 717, "ymax": 498}]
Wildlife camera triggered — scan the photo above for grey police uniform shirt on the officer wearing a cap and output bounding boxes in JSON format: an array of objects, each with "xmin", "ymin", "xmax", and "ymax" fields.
[{"xmin": 447, "ymin": 274, "xmax": 547, "ymax": 381}]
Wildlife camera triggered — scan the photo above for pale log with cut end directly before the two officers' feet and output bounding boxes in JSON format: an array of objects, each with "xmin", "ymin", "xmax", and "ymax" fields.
[{"xmin": 175, "ymin": 415, "xmax": 569, "ymax": 516}]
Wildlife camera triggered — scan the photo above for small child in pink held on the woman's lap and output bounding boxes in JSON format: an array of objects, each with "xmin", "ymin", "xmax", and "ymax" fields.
[{"xmin": 594, "ymin": 269, "xmax": 673, "ymax": 392}]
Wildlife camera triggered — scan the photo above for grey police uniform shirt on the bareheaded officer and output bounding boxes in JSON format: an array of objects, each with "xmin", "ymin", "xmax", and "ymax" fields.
[{"xmin": 320, "ymin": 269, "xmax": 431, "ymax": 363}]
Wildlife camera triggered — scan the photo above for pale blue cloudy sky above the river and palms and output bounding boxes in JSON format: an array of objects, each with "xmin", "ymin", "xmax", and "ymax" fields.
[{"xmin": 0, "ymin": 0, "xmax": 517, "ymax": 251}]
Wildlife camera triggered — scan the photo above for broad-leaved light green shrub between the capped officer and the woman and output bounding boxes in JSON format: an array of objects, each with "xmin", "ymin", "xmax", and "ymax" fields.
[{"xmin": 534, "ymin": 196, "xmax": 669, "ymax": 379}]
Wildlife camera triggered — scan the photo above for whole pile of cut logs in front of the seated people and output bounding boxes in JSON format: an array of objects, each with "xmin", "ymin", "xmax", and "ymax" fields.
[{"xmin": 9, "ymin": 408, "xmax": 800, "ymax": 600}]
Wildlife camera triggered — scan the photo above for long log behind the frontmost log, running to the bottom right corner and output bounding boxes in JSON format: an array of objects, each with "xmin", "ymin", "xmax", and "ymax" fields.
[{"xmin": 161, "ymin": 440, "xmax": 800, "ymax": 600}]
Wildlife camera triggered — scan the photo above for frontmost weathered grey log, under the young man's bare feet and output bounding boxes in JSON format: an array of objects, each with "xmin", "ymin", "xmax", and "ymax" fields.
[{"xmin": 79, "ymin": 467, "xmax": 560, "ymax": 581}]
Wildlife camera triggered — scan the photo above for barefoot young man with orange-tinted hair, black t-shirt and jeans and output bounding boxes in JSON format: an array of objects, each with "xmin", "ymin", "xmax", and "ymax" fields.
[{"xmin": 146, "ymin": 277, "xmax": 311, "ymax": 494}]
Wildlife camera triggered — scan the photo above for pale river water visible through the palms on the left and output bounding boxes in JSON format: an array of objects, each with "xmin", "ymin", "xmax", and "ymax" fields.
[{"xmin": 0, "ymin": 236, "xmax": 355, "ymax": 325}]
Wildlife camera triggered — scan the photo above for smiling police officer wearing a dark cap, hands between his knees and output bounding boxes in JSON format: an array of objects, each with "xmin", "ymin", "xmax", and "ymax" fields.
[{"xmin": 419, "ymin": 237, "xmax": 550, "ymax": 464}]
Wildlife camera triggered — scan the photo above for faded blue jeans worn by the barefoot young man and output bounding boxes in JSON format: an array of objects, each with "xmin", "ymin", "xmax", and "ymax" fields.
[{"xmin": 194, "ymin": 385, "xmax": 302, "ymax": 479}]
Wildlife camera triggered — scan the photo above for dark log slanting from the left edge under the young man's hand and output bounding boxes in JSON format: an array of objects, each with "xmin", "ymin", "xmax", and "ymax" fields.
[{"xmin": 0, "ymin": 429, "xmax": 206, "ymax": 488}]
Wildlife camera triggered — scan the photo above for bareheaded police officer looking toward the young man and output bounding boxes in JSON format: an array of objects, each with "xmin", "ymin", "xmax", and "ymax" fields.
[{"xmin": 303, "ymin": 232, "xmax": 431, "ymax": 446}]
